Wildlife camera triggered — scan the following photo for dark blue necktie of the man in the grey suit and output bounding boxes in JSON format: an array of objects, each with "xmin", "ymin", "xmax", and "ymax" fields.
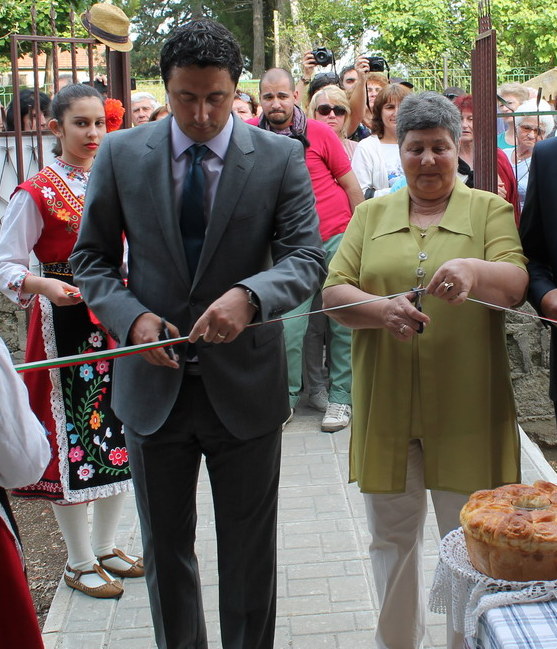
[{"xmin": 180, "ymin": 144, "xmax": 209, "ymax": 282}]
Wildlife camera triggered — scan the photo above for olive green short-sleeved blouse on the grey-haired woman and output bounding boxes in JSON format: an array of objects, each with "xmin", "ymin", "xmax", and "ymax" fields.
[{"xmin": 325, "ymin": 180, "xmax": 526, "ymax": 493}]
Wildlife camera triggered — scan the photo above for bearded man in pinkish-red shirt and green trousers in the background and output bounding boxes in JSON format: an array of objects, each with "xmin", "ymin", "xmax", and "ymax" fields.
[{"xmin": 251, "ymin": 68, "xmax": 363, "ymax": 433}]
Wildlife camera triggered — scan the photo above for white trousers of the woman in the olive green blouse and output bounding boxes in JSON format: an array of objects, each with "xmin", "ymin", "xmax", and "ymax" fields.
[{"xmin": 364, "ymin": 440, "xmax": 468, "ymax": 649}]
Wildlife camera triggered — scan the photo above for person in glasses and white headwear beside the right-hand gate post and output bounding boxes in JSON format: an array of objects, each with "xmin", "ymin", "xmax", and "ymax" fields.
[{"xmin": 503, "ymin": 99, "xmax": 555, "ymax": 210}]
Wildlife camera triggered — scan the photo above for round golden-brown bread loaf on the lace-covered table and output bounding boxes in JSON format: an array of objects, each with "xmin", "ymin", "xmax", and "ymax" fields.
[{"xmin": 460, "ymin": 481, "xmax": 557, "ymax": 581}]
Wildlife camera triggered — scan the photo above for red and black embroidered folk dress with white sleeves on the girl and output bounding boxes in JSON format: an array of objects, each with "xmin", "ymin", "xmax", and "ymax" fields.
[{"xmin": 0, "ymin": 159, "xmax": 131, "ymax": 503}]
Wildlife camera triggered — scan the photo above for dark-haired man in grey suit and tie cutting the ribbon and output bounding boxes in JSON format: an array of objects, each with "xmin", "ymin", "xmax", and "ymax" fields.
[{"xmin": 71, "ymin": 19, "xmax": 324, "ymax": 649}]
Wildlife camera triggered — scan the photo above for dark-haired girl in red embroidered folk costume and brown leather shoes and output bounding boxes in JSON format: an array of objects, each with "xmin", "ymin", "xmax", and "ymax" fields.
[{"xmin": 0, "ymin": 84, "xmax": 143, "ymax": 597}]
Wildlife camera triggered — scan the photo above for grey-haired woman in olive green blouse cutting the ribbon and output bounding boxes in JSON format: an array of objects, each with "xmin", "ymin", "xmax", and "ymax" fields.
[{"xmin": 323, "ymin": 92, "xmax": 527, "ymax": 649}]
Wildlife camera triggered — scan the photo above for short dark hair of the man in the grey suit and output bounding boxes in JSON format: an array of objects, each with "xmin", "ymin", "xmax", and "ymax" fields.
[{"xmin": 160, "ymin": 18, "xmax": 244, "ymax": 86}]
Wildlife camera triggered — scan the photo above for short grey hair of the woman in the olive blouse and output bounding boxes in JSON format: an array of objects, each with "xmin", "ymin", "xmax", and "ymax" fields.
[{"xmin": 396, "ymin": 91, "xmax": 462, "ymax": 148}]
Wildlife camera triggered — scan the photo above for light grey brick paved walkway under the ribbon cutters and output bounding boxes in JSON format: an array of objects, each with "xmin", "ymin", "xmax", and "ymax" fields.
[{"xmin": 44, "ymin": 400, "xmax": 557, "ymax": 649}]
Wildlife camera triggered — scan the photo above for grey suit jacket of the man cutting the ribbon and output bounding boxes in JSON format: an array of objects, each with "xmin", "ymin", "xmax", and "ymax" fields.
[{"xmin": 71, "ymin": 118, "xmax": 325, "ymax": 439}]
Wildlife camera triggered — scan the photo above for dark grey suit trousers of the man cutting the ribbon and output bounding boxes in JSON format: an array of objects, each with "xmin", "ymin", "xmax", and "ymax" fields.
[{"xmin": 125, "ymin": 375, "xmax": 281, "ymax": 649}]
